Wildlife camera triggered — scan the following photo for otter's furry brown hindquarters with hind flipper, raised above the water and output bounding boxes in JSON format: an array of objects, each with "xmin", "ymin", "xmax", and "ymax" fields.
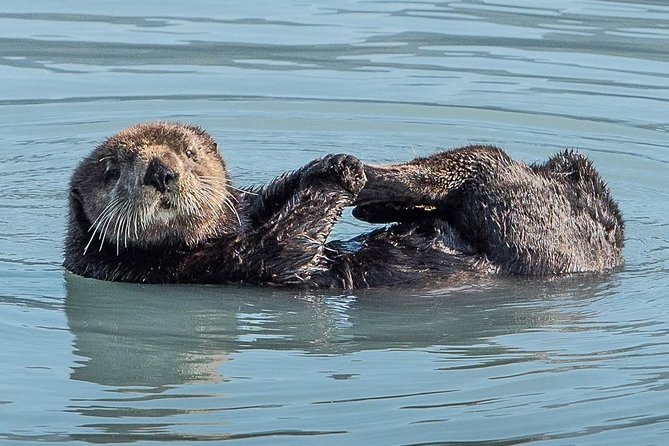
[{"xmin": 341, "ymin": 146, "xmax": 624, "ymax": 286}]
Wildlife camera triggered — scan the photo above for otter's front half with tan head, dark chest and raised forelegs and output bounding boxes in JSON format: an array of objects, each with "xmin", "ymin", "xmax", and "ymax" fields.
[{"xmin": 64, "ymin": 122, "xmax": 365, "ymax": 285}]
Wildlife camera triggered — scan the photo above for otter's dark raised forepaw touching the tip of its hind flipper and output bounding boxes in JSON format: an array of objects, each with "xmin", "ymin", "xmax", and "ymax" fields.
[{"xmin": 309, "ymin": 154, "xmax": 367, "ymax": 196}]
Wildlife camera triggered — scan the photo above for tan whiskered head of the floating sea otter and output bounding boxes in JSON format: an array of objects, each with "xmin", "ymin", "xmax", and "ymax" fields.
[{"xmin": 70, "ymin": 122, "xmax": 237, "ymax": 253}]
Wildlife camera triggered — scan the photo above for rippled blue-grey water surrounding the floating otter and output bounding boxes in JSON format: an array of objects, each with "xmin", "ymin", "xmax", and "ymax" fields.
[{"xmin": 0, "ymin": 0, "xmax": 669, "ymax": 445}]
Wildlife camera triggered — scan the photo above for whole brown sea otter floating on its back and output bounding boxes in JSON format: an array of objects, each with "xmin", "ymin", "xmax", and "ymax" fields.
[{"xmin": 65, "ymin": 123, "xmax": 623, "ymax": 288}]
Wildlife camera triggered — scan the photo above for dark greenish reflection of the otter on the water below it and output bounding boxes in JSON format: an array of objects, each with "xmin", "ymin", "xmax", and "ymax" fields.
[{"xmin": 65, "ymin": 274, "xmax": 596, "ymax": 388}]
